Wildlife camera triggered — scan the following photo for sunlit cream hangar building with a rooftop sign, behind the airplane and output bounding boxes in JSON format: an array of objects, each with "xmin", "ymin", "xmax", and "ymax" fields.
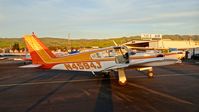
[{"xmin": 125, "ymin": 34, "xmax": 199, "ymax": 49}]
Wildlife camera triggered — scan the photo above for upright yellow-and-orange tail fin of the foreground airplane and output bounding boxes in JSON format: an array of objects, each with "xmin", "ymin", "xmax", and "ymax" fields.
[{"xmin": 24, "ymin": 33, "xmax": 56, "ymax": 65}]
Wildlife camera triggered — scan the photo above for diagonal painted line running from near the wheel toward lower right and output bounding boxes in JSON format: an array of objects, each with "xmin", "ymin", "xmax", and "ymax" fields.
[{"xmin": 128, "ymin": 82, "xmax": 193, "ymax": 105}]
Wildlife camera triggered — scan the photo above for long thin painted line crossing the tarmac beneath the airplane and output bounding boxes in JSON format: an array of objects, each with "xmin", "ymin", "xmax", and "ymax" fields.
[{"xmin": 0, "ymin": 73, "xmax": 198, "ymax": 87}]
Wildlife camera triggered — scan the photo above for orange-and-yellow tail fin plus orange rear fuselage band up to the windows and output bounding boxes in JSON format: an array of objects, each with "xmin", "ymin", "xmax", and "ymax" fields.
[{"xmin": 24, "ymin": 35, "xmax": 92, "ymax": 65}]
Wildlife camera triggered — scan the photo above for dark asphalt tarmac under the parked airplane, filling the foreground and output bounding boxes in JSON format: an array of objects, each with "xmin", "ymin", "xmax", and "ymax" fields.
[{"xmin": 0, "ymin": 61, "xmax": 199, "ymax": 112}]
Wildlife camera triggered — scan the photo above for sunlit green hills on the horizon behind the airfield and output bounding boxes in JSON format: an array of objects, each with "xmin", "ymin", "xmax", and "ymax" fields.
[{"xmin": 0, "ymin": 35, "xmax": 199, "ymax": 50}]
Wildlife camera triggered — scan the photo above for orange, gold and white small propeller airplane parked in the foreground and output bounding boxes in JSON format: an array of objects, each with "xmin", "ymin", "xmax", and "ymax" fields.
[{"xmin": 21, "ymin": 33, "xmax": 180, "ymax": 85}]
